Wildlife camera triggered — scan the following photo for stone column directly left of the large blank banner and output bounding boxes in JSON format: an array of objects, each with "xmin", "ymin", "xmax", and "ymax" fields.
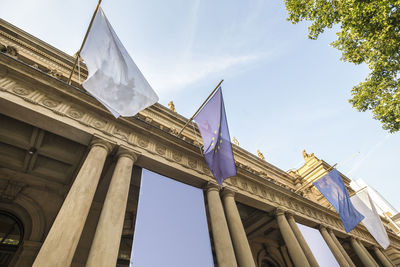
[{"xmin": 86, "ymin": 148, "xmax": 137, "ymax": 267}]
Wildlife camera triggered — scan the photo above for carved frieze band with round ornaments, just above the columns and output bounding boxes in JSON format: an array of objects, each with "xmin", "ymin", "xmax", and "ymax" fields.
[{"xmin": 0, "ymin": 73, "xmax": 398, "ymax": 249}]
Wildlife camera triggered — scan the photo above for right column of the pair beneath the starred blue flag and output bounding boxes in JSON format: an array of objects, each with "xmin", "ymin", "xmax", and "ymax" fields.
[{"xmin": 222, "ymin": 188, "xmax": 256, "ymax": 267}]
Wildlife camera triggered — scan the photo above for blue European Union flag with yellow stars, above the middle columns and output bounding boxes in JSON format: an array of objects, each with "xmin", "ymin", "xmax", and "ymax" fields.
[{"xmin": 194, "ymin": 87, "xmax": 236, "ymax": 185}]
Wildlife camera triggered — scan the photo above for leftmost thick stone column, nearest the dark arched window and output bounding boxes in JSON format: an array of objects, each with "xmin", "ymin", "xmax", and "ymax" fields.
[{"xmin": 33, "ymin": 139, "xmax": 112, "ymax": 267}]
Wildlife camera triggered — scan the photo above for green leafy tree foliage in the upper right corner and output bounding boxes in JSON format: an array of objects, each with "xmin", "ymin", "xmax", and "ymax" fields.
[{"xmin": 285, "ymin": 0, "xmax": 400, "ymax": 132}]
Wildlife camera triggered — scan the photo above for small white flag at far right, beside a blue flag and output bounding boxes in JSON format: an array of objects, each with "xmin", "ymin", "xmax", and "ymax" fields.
[{"xmin": 350, "ymin": 190, "xmax": 390, "ymax": 249}]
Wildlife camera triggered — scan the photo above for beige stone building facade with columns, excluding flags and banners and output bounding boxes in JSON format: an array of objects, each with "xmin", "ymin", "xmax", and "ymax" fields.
[{"xmin": 0, "ymin": 17, "xmax": 400, "ymax": 267}]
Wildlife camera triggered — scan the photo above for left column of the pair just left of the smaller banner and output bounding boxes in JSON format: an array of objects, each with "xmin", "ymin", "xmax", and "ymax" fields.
[{"xmin": 276, "ymin": 209, "xmax": 310, "ymax": 267}]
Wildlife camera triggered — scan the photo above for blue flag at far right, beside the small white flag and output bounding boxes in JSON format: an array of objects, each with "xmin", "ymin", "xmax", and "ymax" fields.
[{"xmin": 313, "ymin": 169, "xmax": 364, "ymax": 232}]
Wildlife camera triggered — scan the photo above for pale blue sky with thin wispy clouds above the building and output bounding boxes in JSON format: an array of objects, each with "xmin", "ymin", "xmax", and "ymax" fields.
[{"xmin": 0, "ymin": 0, "xmax": 400, "ymax": 209}]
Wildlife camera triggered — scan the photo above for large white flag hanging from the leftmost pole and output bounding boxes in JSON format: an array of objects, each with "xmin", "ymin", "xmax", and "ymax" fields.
[{"xmin": 80, "ymin": 7, "xmax": 158, "ymax": 118}]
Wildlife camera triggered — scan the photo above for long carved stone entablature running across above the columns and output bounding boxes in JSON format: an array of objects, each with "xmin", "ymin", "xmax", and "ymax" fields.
[{"xmin": 0, "ymin": 19, "xmax": 400, "ymax": 252}]
